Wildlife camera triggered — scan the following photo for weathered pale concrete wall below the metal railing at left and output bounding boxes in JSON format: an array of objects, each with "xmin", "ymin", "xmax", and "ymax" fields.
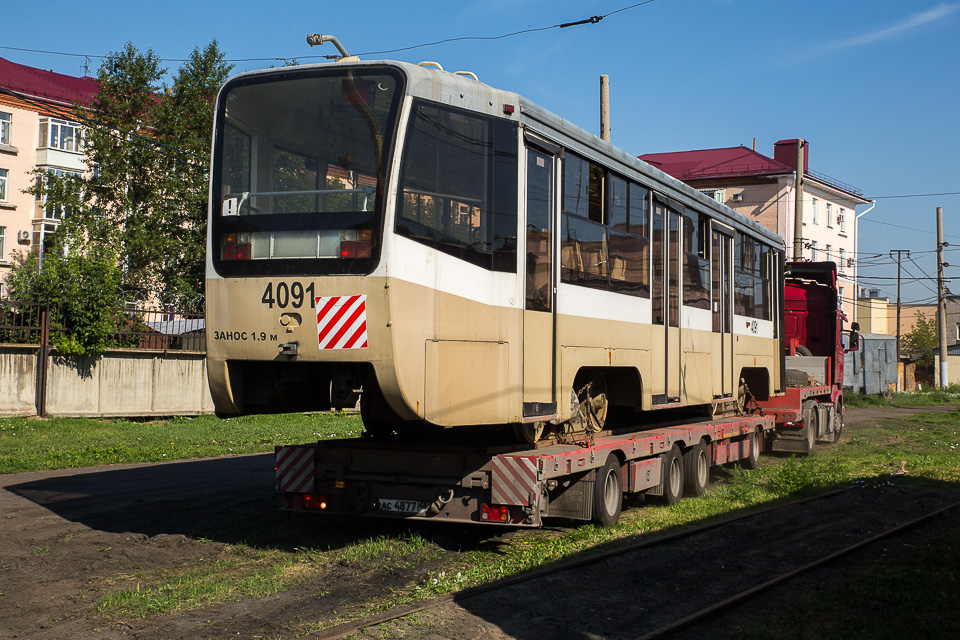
[{"xmin": 0, "ymin": 344, "xmax": 213, "ymax": 417}]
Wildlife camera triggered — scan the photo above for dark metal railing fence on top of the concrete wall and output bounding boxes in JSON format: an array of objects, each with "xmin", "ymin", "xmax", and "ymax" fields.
[{"xmin": 0, "ymin": 300, "xmax": 206, "ymax": 351}]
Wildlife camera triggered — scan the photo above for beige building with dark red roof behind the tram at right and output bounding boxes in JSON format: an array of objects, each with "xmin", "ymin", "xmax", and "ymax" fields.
[{"xmin": 640, "ymin": 139, "xmax": 871, "ymax": 320}]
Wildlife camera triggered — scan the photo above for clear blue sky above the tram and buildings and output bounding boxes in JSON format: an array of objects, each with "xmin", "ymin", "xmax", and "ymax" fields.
[{"xmin": 0, "ymin": 0, "xmax": 960, "ymax": 310}]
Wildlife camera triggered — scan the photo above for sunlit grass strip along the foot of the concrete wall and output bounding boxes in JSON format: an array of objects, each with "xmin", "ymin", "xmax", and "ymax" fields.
[{"xmin": 0, "ymin": 414, "xmax": 363, "ymax": 473}]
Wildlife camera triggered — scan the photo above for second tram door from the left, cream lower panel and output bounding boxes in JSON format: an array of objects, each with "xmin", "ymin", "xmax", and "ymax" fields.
[{"xmin": 651, "ymin": 198, "xmax": 683, "ymax": 405}]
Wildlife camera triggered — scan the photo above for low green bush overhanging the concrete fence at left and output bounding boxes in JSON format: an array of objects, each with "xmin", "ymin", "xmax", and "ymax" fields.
[{"xmin": 1, "ymin": 251, "xmax": 124, "ymax": 356}]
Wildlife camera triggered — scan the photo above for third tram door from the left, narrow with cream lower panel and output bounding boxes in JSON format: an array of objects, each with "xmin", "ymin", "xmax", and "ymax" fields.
[{"xmin": 710, "ymin": 228, "xmax": 734, "ymax": 398}]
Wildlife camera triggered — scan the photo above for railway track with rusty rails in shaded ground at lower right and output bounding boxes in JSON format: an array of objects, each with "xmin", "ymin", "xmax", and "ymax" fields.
[{"xmin": 313, "ymin": 485, "xmax": 960, "ymax": 640}]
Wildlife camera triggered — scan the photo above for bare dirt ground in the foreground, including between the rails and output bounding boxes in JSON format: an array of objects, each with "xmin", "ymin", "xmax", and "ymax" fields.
[{"xmin": 0, "ymin": 407, "xmax": 960, "ymax": 640}]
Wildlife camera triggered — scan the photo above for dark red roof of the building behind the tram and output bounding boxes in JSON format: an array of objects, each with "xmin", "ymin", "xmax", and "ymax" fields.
[{"xmin": 640, "ymin": 146, "xmax": 793, "ymax": 181}]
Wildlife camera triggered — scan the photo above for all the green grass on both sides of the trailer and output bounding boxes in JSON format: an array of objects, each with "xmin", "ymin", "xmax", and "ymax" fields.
[{"xmin": 7, "ymin": 402, "xmax": 960, "ymax": 637}]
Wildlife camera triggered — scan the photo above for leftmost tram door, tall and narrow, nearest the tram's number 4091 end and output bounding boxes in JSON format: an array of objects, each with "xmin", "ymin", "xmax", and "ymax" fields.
[{"xmin": 520, "ymin": 146, "xmax": 557, "ymax": 422}]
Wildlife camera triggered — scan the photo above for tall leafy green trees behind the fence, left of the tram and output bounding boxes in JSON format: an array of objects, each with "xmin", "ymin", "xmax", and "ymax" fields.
[{"xmin": 30, "ymin": 40, "xmax": 231, "ymax": 306}]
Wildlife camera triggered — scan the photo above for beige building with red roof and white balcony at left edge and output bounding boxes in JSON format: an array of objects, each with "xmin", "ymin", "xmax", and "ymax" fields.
[{"xmin": 0, "ymin": 58, "xmax": 97, "ymax": 296}]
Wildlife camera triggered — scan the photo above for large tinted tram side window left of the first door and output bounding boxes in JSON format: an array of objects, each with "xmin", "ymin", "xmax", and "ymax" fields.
[{"xmin": 396, "ymin": 101, "xmax": 517, "ymax": 272}]
